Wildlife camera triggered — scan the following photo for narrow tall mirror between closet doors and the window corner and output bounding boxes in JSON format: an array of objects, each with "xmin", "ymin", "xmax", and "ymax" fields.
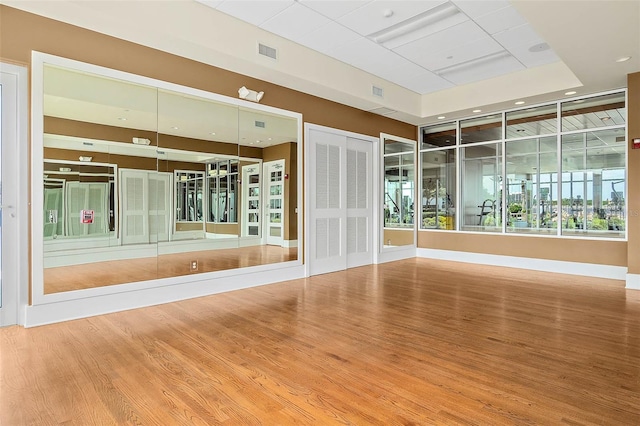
[{"xmin": 383, "ymin": 138, "xmax": 416, "ymax": 247}]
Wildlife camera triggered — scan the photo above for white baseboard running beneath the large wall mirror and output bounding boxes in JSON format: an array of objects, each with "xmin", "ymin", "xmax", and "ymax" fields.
[{"xmin": 25, "ymin": 264, "xmax": 304, "ymax": 327}]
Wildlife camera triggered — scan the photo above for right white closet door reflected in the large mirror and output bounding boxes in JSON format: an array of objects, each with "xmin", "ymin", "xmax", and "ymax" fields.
[{"xmin": 148, "ymin": 173, "xmax": 172, "ymax": 243}]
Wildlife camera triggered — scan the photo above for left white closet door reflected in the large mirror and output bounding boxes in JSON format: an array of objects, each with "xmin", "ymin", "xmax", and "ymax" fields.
[{"xmin": 120, "ymin": 170, "xmax": 150, "ymax": 244}]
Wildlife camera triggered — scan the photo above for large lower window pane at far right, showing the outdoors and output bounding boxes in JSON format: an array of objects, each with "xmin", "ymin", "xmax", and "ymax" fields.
[{"xmin": 562, "ymin": 129, "xmax": 626, "ymax": 238}]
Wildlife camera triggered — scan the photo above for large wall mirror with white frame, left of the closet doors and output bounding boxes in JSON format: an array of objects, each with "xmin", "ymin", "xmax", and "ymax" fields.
[{"xmin": 33, "ymin": 55, "xmax": 301, "ymax": 295}]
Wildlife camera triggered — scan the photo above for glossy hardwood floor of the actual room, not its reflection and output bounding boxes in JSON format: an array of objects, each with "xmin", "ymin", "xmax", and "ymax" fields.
[{"xmin": 0, "ymin": 259, "xmax": 640, "ymax": 426}]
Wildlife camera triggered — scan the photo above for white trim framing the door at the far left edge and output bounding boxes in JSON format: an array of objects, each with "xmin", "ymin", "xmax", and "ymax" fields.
[{"xmin": 0, "ymin": 62, "xmax": 29, "ymax": 325}]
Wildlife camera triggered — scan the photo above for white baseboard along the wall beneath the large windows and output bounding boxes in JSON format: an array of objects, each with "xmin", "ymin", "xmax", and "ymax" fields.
[{"xmin": 416, "ymin": 248, "xmax": 627, "ymax": 280}]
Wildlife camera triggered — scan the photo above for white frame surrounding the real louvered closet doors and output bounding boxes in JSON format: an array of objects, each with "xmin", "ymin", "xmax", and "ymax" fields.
[{"xmin": 304, "ymin": 122, "xmax": 380, "ymax": 277}]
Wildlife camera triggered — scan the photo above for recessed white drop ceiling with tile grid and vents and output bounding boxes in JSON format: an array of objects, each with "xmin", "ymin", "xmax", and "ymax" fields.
[{"xmin": 206, "ymin": 0, "xmax": 558, "ymax": 94}]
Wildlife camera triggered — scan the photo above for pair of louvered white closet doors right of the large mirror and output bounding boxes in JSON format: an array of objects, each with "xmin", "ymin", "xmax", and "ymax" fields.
[{"xmin": 308, "ymin": 129, "xmax": 374, "ymax": 275}]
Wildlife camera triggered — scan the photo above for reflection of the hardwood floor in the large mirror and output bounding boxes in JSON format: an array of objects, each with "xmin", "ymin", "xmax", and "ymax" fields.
[{"xmin": 44, "ymin": 245, "xmax": 298, "ymax": 294}]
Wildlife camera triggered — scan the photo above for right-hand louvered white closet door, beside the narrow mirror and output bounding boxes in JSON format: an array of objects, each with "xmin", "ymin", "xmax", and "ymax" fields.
[{"xmin": 346, "ymin": 138, "xmax": 374, "ymax": 268}]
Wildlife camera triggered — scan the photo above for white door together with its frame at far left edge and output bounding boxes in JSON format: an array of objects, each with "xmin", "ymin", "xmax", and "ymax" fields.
[{"xmin": 0, "ymin": 62, "xmax": 30, "ymax": 326}]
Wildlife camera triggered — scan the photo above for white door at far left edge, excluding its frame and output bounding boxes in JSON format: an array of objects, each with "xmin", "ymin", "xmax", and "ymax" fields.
[{"xmin": 0, "ymin": 64, "xmax": 26, "ymax": 326}]
